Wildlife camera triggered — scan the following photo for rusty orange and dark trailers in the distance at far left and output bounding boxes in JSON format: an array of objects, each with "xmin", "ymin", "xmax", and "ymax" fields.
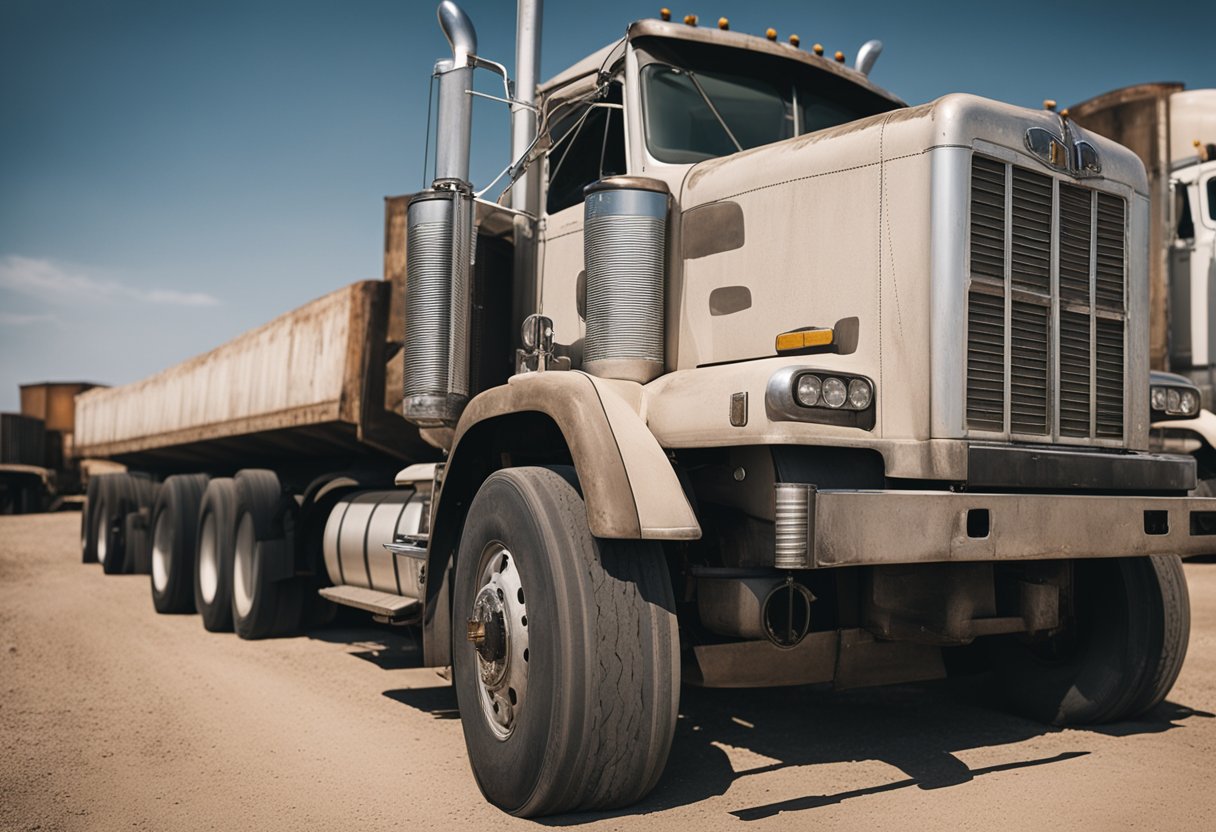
[{"xmin": 0, "ymin": 382, "xmax": 100, "ymax": 515}]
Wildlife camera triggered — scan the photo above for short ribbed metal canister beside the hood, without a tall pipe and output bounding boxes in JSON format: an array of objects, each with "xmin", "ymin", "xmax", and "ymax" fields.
[{"xmin": 582, "ymin": 176, "xmax": 669, "ymax": 384}]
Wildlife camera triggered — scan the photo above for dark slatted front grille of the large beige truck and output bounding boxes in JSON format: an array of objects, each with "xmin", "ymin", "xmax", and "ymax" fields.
[{"xmin": 966, "ymin": 156, "xmax": 1127, "ymax": 440}]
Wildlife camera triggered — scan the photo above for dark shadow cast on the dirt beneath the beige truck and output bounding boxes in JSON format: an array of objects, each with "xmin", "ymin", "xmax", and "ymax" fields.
[{"xmin": 309, "ymin": 629, "xmax": 1214, "ymax": 826}]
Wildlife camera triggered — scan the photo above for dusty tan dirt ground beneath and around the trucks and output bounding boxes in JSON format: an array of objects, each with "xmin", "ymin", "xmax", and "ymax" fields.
[{"xmin": 0, "ymin": 515, "xmax": 1216, "ymax": 832}]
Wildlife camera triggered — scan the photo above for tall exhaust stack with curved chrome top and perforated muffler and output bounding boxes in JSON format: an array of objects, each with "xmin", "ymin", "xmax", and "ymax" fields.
[{"xmin": 402, "ymin": 0, "xmax": 477, "ymax": 427}]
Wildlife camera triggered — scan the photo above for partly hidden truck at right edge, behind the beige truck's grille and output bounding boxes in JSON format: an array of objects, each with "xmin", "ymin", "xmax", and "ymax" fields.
[{"xmin": 1064, "ymin": 83, "xmax": 1216, "ymax": 484}]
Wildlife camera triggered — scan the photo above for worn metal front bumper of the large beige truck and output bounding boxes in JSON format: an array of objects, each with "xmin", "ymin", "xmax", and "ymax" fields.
[{"xmin": 807, "ymin": 489, "xmax": 1216, "ymax": 567}]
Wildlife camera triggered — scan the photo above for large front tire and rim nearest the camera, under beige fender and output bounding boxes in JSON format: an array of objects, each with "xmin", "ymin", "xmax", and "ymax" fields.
[{"xmin": 452, "ymin": 468, "xmax": 680, "ymax": 817}]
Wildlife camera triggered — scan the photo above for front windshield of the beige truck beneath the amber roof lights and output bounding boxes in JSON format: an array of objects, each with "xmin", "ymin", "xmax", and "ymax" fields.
[{"xmin": 642, "ymin": 41, "xmax": 896, "ymax": 164}]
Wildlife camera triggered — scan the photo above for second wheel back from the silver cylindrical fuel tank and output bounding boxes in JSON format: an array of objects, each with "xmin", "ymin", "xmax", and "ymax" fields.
[{"xmin": 193, "ymin": 477, "xmax": 236, "ymax": 633}]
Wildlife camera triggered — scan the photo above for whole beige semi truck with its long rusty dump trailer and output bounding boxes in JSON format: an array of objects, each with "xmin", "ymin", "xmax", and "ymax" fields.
[{"xmin": 77, "ymin": 0, "xmax": 1216, "ymax": 816}]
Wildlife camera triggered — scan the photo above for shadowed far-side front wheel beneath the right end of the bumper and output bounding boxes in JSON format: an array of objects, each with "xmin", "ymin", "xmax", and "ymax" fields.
[{"xmin": 993, "ymin": 555, "xmax": 1190, "ymax": 725}]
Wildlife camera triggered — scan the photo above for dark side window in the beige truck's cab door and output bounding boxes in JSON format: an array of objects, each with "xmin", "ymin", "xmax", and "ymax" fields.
[{"xmin": 545, "ymin": 84, "xmax": 625, "ymax": 214}]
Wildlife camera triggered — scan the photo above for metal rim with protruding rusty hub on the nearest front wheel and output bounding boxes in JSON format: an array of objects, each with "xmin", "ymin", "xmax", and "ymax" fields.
[{"xmin": 468, "ymin": 543, "xmax": 529, "ymax": 740}]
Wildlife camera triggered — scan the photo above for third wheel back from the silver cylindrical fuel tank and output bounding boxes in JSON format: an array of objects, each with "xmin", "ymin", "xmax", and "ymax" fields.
[{"xmin": 148, "ymin": 474, "xmax": 208, "ymax": 613}]
